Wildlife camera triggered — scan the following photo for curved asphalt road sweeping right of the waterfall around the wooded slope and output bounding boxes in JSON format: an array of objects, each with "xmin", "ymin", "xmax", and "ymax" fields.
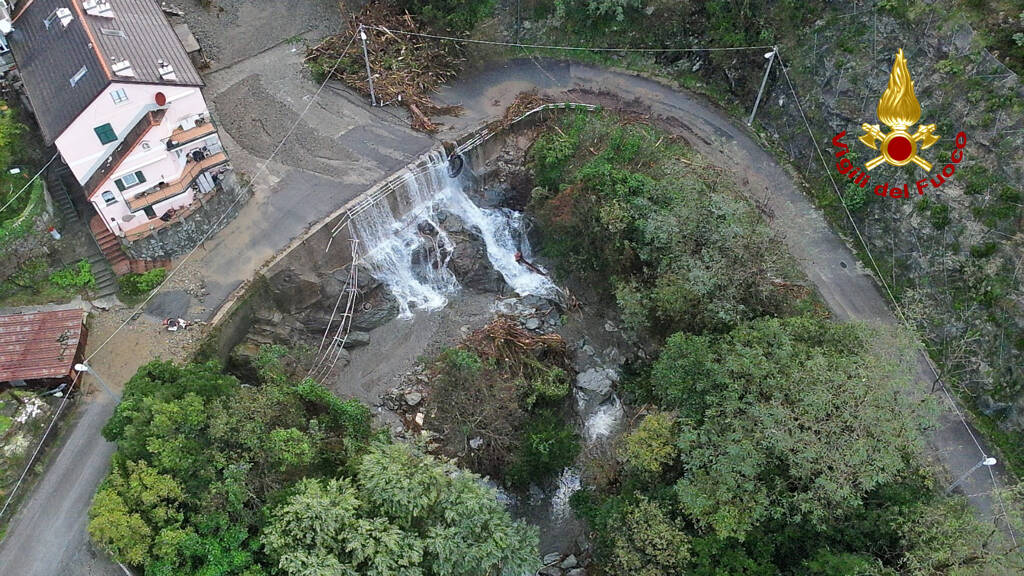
[{"xmin": 437, "ymin": 58, "xmax": 1008, "ymax": 519}]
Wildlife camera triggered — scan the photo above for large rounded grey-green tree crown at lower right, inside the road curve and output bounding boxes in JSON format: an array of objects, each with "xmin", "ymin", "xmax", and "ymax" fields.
[{"xmin": 651, "ymin": 318, "xmax": 928, "ymax": 537}]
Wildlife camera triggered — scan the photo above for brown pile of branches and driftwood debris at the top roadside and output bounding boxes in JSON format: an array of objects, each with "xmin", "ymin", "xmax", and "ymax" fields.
[{"xmin": 305, "ymin": 2, "xmax": 463, "ymax": 132}]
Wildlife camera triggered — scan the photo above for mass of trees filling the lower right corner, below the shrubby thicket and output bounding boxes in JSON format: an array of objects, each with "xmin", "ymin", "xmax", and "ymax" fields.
[{"xmin": 575, "ymin": 317, "xmax": 1021, "ymax": 576}]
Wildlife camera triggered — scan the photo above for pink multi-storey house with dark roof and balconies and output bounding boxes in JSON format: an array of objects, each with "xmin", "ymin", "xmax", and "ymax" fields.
[{"xmin": 7, "ymin": 0, "xmax": 229, "ymax": 242}]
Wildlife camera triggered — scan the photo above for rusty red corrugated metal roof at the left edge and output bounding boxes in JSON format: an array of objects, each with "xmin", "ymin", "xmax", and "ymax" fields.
[{"xmin": 0, "ymin": 306, "xmax": 85, "ymax": 382}]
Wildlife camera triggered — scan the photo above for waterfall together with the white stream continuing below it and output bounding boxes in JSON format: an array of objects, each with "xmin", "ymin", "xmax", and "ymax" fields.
[{"xmin": 351, "ymin": 151, "xmax": 625, "ymax": 554}]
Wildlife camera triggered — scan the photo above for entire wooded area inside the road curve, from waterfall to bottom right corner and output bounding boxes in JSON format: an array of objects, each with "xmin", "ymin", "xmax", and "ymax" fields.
[{"xmin": 530, "ymin": 117, "xmax": 1022, "ymax": 576}]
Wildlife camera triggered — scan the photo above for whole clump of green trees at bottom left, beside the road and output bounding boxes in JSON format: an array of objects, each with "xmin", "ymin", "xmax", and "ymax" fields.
[{"xmin": 89, "ymin": 349, "xmax": 537, "ymax": 576}]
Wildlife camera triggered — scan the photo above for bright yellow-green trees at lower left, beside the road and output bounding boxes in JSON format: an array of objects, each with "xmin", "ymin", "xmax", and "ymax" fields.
[{"xmin": 90, "ymin": 356, "xmax": 372, "ymax": 576}]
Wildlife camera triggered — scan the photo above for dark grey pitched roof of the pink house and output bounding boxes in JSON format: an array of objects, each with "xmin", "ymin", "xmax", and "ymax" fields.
[{"xmin": 8, "ymin": 0, "xmax": 203, "ymax": 143}]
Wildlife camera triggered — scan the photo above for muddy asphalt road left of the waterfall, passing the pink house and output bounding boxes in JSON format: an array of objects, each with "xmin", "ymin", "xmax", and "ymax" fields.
[{"xmin": 0, "ymin": 44, "xmax": 434, "ymax": 576}]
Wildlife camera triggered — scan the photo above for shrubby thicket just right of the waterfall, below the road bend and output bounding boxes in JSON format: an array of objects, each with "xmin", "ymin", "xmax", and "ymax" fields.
[{"xmin": 529, "ymin": 114, "xmax": 791, "ymax": 334}]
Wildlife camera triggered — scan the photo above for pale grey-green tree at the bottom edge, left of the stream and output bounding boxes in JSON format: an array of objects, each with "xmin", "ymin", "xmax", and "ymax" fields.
[{"xmin": 263, "ymin": 444, "xmax": 538, "ymax": 576}]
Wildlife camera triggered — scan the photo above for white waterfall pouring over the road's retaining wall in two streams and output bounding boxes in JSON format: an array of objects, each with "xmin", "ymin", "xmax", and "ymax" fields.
[{"xmin": 352, "ymin": 152, "xmax": 555, "ymax": 317}]
